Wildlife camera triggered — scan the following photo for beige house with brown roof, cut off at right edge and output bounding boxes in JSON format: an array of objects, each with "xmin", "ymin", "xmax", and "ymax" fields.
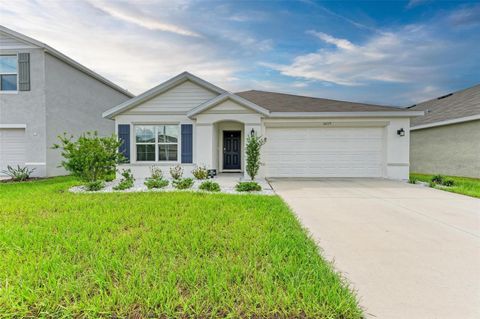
[{"xmin": 409, "ymin": 84, "xmax": 480, "ymax": 178}]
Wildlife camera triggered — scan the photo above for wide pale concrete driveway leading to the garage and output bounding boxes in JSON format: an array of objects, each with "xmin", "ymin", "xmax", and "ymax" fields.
[{"xmin": 271, "ymin": 179, "xmax": 480, "ymax": 319}]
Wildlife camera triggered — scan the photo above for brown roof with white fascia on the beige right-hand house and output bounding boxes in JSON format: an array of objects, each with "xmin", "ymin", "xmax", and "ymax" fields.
[{"xmin": 408, "ymin": 84, "xmax": 480, "ymax": 128}]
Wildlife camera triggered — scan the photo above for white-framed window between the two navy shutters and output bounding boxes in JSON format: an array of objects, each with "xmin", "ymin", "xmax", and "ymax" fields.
[{"xmin": 135, "ymin": 125, "xmax": 179, "ymax": 162}]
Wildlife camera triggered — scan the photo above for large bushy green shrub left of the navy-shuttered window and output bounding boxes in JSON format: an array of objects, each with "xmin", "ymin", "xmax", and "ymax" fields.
[{"xmin": 53, "ymin": 132, "xmax": 125, "ymax": 182}]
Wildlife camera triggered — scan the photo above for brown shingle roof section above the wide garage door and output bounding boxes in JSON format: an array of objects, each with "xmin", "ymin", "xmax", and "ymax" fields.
[{"xmin": 235, "ymin": 90, "xmax": 405, "ymax": 113}]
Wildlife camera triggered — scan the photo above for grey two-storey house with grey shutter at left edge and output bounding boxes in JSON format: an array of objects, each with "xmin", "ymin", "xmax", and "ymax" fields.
[{"xmin": 0, "ymin": 26, "xmax": 133, "ymax": 176}]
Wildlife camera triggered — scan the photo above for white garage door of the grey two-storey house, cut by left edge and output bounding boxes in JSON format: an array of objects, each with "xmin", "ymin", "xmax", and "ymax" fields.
[{"xmin": 0, "ymin": 129, "xmax": 25, "ymax": 176}]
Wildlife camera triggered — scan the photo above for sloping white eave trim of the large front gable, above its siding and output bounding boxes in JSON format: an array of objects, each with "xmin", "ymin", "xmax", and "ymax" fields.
[{"xmin": 102, "ymin": 71, "xmax": 226, "ymax": 118}]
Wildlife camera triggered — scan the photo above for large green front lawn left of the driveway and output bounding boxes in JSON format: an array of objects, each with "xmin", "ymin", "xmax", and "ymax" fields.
[{"xmin": 0, "ymin": 177, "xmax": 362, "ymax": 318}]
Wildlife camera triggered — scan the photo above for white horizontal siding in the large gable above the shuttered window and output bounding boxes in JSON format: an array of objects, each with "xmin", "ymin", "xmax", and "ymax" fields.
[{"xmin": 124, "ymin": 81, "xmax": 218, "ymax": 114}]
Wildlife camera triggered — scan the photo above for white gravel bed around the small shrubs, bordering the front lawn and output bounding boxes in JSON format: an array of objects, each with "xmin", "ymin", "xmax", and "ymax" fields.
[{"xmin": 69, "ymin": 178, "xmax": 275, "ymax": 195}]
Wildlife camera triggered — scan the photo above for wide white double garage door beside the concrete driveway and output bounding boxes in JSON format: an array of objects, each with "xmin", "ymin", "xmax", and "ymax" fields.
[{"xmin": 265, "ymin": 127, "xmax": 383, "ymax": 177}]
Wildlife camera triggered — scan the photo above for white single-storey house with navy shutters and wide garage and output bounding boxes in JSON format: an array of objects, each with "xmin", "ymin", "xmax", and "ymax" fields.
[{"xmin": 103, "ymin": 72, "xmax": 423, "ymax": 179}]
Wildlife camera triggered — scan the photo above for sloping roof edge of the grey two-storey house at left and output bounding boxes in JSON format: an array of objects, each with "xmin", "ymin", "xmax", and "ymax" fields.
[{"xmin": 0, "ymin": 25, "xmax": 134, "ymax": 97}]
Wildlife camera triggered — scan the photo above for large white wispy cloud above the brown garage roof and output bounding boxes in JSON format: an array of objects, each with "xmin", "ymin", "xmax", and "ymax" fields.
[{"xmin": 267, "ymin": 26, "xmax": 449, "ymax": 86}]
